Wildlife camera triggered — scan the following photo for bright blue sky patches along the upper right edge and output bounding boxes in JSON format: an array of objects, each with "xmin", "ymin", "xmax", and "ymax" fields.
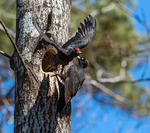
[{"xmin": 130, "ymin": 0, "xmax": 150, "ymax": 88}]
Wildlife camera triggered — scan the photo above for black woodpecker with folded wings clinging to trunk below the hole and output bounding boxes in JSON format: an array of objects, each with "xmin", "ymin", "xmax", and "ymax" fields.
[{"xmin": 64, "ymin": 56, "xmax": 89, "ymax": 104}]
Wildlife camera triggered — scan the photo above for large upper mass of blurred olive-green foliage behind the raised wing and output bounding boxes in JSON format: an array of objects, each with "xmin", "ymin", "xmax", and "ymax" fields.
[{"xmin": 72, "ymin": 1, "xmax": 137, "ymax": 72}]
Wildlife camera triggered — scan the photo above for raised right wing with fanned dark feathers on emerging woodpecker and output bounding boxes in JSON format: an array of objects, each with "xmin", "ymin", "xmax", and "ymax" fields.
[{"xmin": 62, "ymin": 15, "xmax": 96, "ymax": 49}]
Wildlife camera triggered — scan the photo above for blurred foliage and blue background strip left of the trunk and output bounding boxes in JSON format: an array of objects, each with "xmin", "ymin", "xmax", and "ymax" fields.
[{"xmin": 0, "ymin": 0, "xmax": 16, "ymax": 132}]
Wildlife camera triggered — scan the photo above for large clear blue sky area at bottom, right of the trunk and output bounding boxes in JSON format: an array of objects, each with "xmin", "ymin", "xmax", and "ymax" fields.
[{"xmin": 72, "ymin": 94, "xmax": 150, "ymax": 133}]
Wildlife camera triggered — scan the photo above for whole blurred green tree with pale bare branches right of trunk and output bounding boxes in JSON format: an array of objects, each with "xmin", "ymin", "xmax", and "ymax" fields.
[{"xmin": 71, "ymin": 0, "xmax": 149, "ymax": 115}]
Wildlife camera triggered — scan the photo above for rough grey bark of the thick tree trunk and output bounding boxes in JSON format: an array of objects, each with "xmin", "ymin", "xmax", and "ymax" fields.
[{"xmin": 13, "ymin": 0, "xmax": 71, "ymax": 133}]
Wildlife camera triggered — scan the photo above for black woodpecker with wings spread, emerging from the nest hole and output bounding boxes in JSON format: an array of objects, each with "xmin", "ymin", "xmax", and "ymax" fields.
[{"xmin": 34, "ymin": 15, "xmax": 96, "ymax": 69}]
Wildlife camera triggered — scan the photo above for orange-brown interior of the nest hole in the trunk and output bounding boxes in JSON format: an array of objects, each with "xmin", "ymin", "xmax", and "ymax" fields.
[{"xmin": 42, "ymin": 49, "xmax": 58, "ymax": 72}]
